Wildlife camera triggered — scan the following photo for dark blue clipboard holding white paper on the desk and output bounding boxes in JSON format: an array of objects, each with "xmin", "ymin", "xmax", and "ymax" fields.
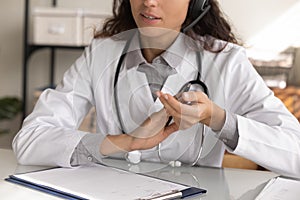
[{"xmin": 5, "ymin": 165, "xmax": 206, "ymax": 200}]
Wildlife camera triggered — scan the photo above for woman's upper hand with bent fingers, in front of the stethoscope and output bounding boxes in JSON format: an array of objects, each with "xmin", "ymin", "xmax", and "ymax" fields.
[{"xmin": 157, "ymin": 91, "xmax": 225, "ymax": 131}]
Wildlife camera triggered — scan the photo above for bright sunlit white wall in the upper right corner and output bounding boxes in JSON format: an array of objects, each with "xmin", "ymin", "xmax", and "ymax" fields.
[{"xmin": 220, "ymin": 0, "xmax": 300, "ymax": 86}]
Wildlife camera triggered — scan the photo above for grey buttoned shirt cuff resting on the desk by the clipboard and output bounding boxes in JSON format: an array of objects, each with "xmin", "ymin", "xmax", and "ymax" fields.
[{"xmin": 71, "ymin": 133, "xmax": 105, "ymax": 166}]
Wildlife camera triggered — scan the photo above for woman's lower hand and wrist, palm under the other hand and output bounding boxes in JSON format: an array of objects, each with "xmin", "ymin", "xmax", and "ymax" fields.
[{"xmin": 100, "ymin": 109, "xmax": 178, "ymax": 155}]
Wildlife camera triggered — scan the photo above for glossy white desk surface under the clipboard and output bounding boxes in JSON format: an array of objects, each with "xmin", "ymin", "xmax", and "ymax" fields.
[{"xmin": 0, "ymin": 149, "xmax": 277, "ymax": 200}]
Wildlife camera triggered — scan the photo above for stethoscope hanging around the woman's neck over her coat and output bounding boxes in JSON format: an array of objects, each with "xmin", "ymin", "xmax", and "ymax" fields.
[{"xmin": 114, "ymin": 31, "xmax": 209, "ymax": 166}]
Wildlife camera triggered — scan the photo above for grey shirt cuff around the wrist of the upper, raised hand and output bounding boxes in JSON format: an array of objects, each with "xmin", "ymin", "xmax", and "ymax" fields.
[{"xmin": 216, "ymin": 111, "xmax": 239, "ymax": 150}]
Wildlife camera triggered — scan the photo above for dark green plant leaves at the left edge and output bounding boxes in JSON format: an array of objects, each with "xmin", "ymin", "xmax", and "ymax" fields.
[{"xmin": 0, "ymin": 97, "xmax": 22, "ymax": 133}]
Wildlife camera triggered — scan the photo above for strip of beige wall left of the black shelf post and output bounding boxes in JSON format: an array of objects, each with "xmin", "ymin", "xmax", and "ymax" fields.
[{"xmin": 0, "ymin": 0, "xmax": 24, "ymax": 96}]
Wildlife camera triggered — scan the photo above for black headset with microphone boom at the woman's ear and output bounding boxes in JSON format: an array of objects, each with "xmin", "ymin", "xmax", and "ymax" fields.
[{"xmin": 181, "ymin": 0, "xmax": 211, "ymax": 33}]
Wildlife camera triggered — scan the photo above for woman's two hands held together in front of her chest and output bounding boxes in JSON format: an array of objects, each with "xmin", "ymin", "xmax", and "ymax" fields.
[{"xmin": 100, "ymin": 91, "xmax": 225, "ymax": 155}]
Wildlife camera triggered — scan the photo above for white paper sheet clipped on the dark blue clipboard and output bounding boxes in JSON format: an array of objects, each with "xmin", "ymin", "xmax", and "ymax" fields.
[{"xmin": 14, "ymin": 165, "xmax": 188, "ymax": 200}]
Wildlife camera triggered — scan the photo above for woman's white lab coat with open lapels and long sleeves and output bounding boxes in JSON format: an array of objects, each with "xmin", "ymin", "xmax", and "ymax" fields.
[{"xmin": 13, "ymin": 35, "xmax": 300, "ymax": 177}]
